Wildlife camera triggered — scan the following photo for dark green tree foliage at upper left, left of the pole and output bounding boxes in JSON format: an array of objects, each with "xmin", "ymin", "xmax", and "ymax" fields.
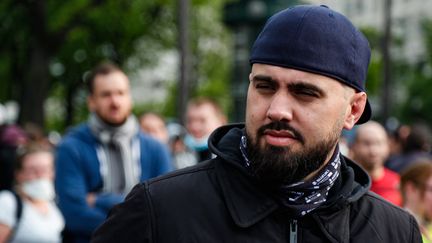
[{"xmin": 0, "ymin": 0, "xmax": 175, "ymax": 132}]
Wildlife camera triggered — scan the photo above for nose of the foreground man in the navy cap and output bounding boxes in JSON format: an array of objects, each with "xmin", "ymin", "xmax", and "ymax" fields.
[{"xmin": 267, "ymin": 92, "xmax": 293, "ymax": 122}]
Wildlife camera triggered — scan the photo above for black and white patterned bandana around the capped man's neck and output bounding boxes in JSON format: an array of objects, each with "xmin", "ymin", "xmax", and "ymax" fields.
[{"xmin": 240, "ymin": 135, "xmax": 341, "ymax": 218}]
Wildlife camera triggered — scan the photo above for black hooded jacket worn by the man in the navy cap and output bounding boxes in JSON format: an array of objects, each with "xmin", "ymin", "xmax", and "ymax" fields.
[{"xmin": 92, "ymin": 125, "xmax": 421, "ymax": 243}]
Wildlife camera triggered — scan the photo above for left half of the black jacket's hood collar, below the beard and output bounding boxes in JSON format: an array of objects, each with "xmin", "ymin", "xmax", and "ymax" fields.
[{"xmin": 209, "ymin": 124, "xmax": 278, "ymax": 228}]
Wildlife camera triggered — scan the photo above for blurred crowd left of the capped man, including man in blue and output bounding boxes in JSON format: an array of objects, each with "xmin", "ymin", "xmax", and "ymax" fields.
[{"xmin": 0, "ymin": 63, "xmax": 226, "ymax": 243}]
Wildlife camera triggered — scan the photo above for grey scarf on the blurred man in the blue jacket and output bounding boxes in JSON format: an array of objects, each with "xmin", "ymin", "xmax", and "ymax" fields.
[{"xmin": 89, "ymin": 114, "xmax": 141, "ymax": 194}]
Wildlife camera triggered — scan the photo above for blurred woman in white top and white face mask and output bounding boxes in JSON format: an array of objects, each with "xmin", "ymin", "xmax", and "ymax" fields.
[{"xmin": 0, "ymin": 144, "xmax": 64, "ymax": 243}]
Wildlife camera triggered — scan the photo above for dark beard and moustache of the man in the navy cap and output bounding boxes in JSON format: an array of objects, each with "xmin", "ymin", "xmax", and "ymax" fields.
[{"xmin": 246, "ymin": 122, "xmax": 341, "ymax": 188}]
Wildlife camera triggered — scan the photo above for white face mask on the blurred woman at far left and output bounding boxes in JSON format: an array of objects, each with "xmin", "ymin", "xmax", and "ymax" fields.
[{"xmin": 22, "ymin": 178, "xmax": 55, "ymax": 201}]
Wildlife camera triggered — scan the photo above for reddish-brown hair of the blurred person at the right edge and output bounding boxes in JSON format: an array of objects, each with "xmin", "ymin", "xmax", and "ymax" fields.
[{"xmin": 400, "ymin": 160, "xmax": 432, "ymax": 201}]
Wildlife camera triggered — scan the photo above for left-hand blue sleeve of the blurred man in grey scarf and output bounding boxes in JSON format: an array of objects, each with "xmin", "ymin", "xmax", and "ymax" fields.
[{"xmin": 55, "ymin": 141, "xmax": 123, "ymax": 235}]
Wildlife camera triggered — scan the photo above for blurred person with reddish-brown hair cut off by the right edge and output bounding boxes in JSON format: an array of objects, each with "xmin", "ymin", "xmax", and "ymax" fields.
[{"xmin": 401, "ymin": 161, "xmax": 432, "ymax": 243}]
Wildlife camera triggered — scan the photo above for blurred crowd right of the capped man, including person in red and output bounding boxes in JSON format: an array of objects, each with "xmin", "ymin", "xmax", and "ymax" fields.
[{"xmin": 340, "ymin": 121, "xmax": 432, "ymax": 242}]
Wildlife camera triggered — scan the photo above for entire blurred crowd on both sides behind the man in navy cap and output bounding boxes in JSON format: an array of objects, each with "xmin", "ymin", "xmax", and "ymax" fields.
[{"xmin": 0, "ymin": 63, "xmax": 432, "ymax": 243}]
